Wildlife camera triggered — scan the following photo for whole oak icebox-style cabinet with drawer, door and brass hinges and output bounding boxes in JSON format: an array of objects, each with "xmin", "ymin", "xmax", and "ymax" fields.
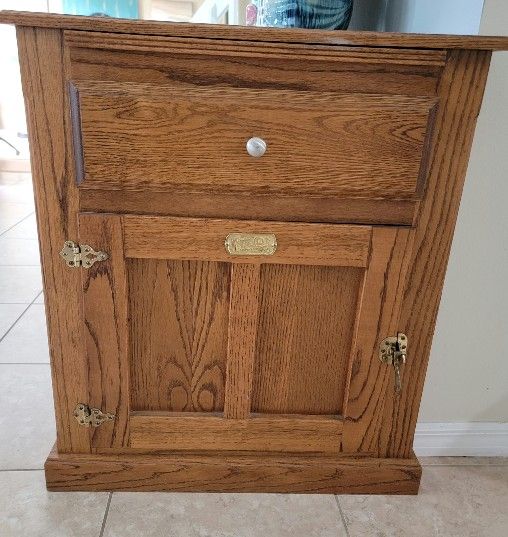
[{"xmin": 0, "ymin": 12, "xmax": 508, "ymax": 493}]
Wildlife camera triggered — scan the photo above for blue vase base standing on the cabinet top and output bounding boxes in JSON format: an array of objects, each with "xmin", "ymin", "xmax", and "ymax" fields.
[{"xmin": 255, "ymin": 0, "xmax": 353, "ymax": 30}]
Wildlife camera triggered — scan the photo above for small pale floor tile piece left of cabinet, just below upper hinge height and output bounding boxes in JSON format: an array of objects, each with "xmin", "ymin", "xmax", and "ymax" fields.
[{"xmin": 0, "ymin": 267, "xmax": 42, "ymax": 304}]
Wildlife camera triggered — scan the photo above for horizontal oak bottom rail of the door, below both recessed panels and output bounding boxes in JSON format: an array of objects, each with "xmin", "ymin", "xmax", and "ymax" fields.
[{"xmin": 130, "ymin": 412, "xmax": 342, "ymax": 453}]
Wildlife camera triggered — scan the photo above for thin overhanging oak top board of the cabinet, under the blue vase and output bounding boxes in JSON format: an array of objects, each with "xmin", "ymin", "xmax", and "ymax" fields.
[{"xmin": 0, "ymin": 11, "xmax": 508, "ymax": 50}]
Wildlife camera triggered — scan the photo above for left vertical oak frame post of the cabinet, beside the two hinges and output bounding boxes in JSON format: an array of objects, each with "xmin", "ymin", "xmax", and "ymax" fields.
[{"xmin": 17, "ymin": 28, "xmax": 90, "ymax": 453}]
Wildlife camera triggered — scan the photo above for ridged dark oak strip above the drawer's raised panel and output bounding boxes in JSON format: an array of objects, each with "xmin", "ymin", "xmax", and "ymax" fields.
[{"xmin": 67, "ymin": 40, "xmax": 443, "ymax": 97}]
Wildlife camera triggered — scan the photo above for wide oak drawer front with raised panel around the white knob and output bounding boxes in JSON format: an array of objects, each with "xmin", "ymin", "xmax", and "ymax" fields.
[{"xmin": 65, "ymin": 32, "xmax": 445, "ymax": 225}]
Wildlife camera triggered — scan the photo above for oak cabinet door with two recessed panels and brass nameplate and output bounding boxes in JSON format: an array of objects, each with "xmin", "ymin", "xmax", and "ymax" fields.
[{"xmin": 79, "ymin": 213, "xmax": 410, "ymax": 453}]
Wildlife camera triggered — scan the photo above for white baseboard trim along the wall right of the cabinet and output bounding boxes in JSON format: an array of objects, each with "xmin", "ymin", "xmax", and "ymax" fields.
[{"xmin": 414, "ymin": 422, "xmax": 508, "ymax": 457}]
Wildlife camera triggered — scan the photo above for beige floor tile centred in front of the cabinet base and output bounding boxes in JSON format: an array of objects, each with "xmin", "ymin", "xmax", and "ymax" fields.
[{"xmin": 104, "ymin": 492, "xmax": 346, "ymax": 537}]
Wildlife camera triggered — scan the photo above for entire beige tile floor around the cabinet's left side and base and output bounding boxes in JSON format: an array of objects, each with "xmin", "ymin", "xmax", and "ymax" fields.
[{"xmin": 0, "ymin": 174, "xmax": 508, "ymax": 537}]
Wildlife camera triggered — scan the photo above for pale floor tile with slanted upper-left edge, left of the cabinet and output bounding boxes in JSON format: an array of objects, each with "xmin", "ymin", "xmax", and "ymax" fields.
[{"xmin": 0, "ymin": 304, "xmax": 49, "ymax": 364}]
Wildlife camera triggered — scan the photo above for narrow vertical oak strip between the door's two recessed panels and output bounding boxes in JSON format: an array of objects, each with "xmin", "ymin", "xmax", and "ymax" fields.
[{"xmin": 224, "ymin": 263, "xmax": 261, "ymax": 419}]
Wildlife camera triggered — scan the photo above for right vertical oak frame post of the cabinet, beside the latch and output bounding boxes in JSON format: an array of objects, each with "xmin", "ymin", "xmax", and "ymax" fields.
[{"xmin": 380, "ymin": 51, "xmax": 491, "ymax": 457}]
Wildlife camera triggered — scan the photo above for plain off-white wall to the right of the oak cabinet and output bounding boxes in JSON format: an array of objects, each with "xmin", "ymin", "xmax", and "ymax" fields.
[{"xmin": 420, "ymin": 0, "xmax": 508, "ymax": 422}]
